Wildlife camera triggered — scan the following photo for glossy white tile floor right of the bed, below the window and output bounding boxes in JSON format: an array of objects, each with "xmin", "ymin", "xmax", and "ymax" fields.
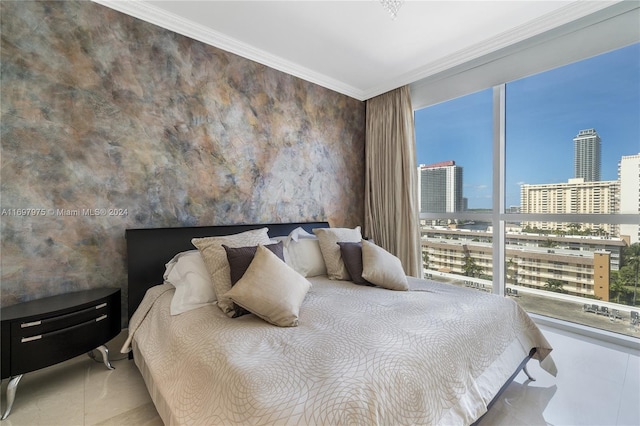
[{"xmin": 480, "ymin": 326, "xmax": 640, "ymax": 426}]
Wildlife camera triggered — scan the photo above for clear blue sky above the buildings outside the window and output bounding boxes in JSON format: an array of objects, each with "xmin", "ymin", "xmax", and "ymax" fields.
[{"xmin": 415, "ymin": 44, "xmax": 640, "ymax": 208}]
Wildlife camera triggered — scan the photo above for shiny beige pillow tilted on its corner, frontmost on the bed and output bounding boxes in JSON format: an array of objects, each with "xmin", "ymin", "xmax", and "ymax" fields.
[{"xmin": 225, "ymin": 246, "xmax": 311, "ymax": 327}]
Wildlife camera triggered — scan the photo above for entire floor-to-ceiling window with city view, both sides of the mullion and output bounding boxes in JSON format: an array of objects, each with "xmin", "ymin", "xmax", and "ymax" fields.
[{"xmin": 415, "ymin": 44, "xmax": 640, "ymax": 337}]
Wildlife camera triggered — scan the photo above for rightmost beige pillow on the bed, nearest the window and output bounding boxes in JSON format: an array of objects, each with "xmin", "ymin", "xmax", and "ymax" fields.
[{"xmin": 362, "ymin": 240, "xmax": 409, "ymax": 290}]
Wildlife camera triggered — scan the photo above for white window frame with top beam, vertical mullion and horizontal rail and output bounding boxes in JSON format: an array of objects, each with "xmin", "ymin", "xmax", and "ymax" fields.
[{"xmin": 410, "ymin": 1, "xmax": 640, "ymax": 347}]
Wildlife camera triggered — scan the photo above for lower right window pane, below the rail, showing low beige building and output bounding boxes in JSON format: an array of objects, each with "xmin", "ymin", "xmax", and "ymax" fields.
[{"xmin": 506, "ymin": 223, "xmax": 640, "ymax": 337}]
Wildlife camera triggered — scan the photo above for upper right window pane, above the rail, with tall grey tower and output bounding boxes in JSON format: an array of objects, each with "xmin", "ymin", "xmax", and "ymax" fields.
[{"xmin": 505, "ymin": 44, "xmax": 640, "ymax": 216}]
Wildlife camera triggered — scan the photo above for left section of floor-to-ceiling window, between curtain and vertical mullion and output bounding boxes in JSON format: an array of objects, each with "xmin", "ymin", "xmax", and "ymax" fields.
[{"xmin": 415, "ymin": 89, "xmax": 493, "ymax": 284}]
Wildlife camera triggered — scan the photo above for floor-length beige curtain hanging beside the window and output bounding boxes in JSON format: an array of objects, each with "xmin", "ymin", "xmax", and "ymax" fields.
[{"xmin": 364, "ymin": 86, "xmax": 422, "ymax": 277}]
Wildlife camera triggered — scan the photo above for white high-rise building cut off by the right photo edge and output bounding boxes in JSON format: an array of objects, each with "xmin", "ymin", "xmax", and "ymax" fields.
[{"xmin": 618, "ymin": 154, "xmax": 640, "ymax": 244}]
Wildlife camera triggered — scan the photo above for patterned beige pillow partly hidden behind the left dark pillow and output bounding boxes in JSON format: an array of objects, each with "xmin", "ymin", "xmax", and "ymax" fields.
[{"xmin": 191, "ymin": 228, "xmax": 269, "ymax": 317}]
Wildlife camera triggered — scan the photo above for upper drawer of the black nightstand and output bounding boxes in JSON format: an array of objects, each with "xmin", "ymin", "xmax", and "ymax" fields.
[{"xmin": 12, "ymin": 302, "xmax": 109, "ymax": 339}]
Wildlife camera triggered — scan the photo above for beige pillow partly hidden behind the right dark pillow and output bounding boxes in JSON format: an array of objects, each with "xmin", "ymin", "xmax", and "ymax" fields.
[{"xmin": 313, "ymin": 226, "xmax": 362, "ymax": 281}]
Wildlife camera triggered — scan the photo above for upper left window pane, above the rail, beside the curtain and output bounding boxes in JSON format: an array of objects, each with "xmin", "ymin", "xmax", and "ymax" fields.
[{"xmin": 415, "ymin": 89, "xmax": 493, "ymax": 213}]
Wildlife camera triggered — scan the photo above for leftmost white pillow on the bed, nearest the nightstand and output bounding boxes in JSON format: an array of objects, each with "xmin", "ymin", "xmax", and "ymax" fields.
[{"xmin": 164, "ymin": 250, "xmax": 216, "ymax": 315}]
